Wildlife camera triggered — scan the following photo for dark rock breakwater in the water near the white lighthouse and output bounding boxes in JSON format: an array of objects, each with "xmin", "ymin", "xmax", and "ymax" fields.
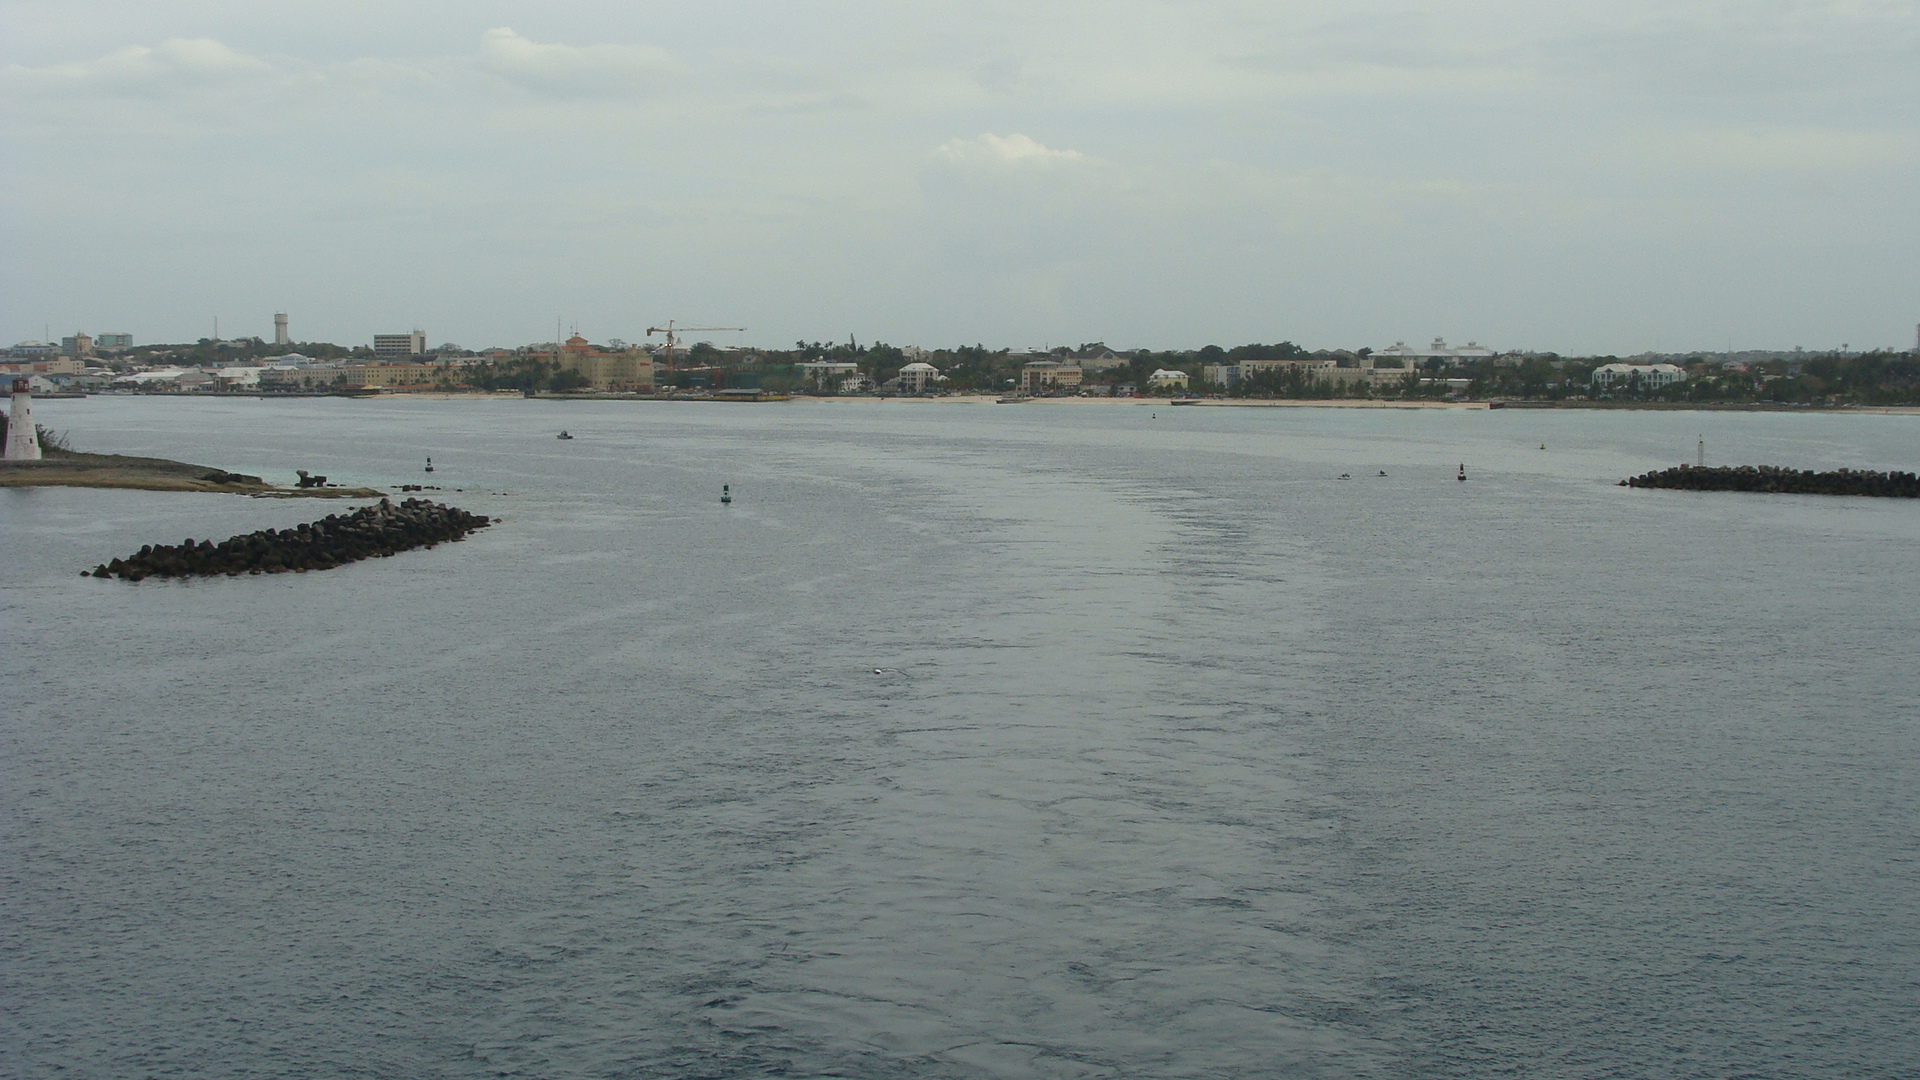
[{"xmin": 84, "ymin": 500, "xmax": 492, "ymax": 580}]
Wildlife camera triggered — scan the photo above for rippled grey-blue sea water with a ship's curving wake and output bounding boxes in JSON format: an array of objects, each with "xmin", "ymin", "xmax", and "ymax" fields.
[{"xmin": 0, "ymin": 398, "xmax": 1920, "ymax": 1080}]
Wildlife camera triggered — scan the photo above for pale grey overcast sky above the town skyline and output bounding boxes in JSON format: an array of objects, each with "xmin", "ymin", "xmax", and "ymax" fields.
[{"xmin": 0, "ymin": 0, "xmax": 1920, "ymax": 354}]
